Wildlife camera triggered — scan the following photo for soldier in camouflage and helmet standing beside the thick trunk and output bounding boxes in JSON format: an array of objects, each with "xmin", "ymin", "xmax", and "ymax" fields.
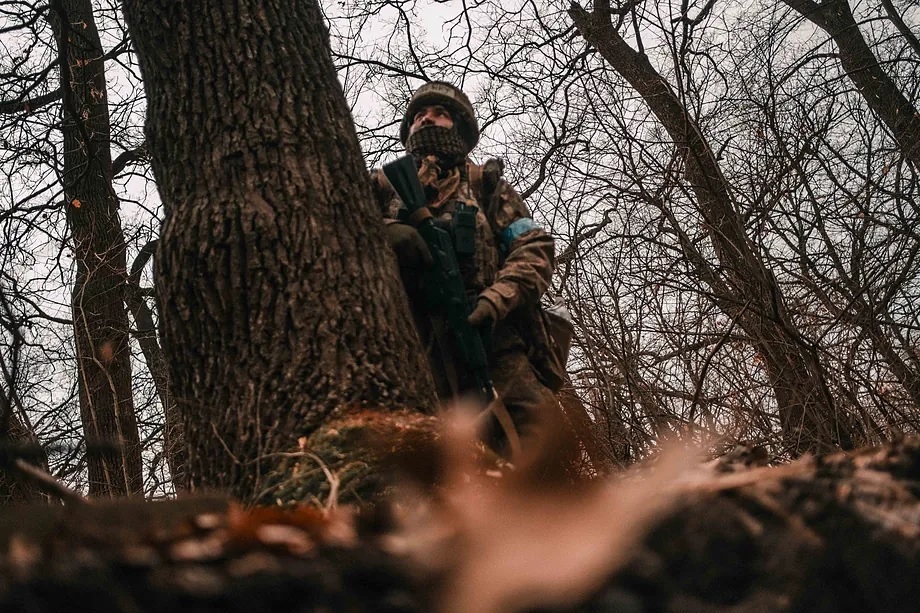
[{"xmin": 372, "ymin": 81, "xmax": 564, "ymax": 464}]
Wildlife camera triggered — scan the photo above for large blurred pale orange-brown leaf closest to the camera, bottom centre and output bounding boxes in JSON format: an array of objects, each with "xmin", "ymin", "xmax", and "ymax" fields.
[{"xmin": 387, "ymin": 416, "xmax": 697, "ymax": 613}]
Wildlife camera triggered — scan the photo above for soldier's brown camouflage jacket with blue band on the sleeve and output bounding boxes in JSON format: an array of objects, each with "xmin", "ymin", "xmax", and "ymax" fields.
[{"xmin": 371, "ymin": 160, "xmax": 555, "ymax": 319}]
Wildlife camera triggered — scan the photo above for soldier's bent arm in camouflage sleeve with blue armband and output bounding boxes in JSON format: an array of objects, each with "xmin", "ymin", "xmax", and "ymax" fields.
[{"xmin": 480, "ymin": 179, "xmax": 555, "ymax": 319}]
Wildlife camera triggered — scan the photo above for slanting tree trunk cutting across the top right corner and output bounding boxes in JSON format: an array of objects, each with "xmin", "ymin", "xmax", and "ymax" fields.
[{"xmin": 783, "ymin": 0, "xmax": 920, "ymax": 169}]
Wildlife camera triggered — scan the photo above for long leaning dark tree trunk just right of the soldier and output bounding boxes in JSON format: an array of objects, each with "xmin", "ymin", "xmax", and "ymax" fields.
[{"xmin": 569, "ymin": 2, "xmax": 853, "ymax": 455}]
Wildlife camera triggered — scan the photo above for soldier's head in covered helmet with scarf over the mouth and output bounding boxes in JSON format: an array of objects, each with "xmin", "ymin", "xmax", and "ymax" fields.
[{"xmin": 399, "ymin": 81, "xmax": 479, "ymax": 165}]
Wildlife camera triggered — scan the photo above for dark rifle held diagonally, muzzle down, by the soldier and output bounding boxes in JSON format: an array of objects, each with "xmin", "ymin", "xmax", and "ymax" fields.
[{"xmin": 383, "ymin": 155, "xmax": 520, "ymax": 458}]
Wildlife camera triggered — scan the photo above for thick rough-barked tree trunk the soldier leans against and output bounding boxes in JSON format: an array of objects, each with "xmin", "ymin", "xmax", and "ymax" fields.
[{"xmin": 124, "ymin": 0, "xmax": 435, "ymax": 499}]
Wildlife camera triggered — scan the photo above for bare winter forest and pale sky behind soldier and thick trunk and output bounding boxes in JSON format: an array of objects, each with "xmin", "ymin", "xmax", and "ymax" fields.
[{"xmin": 0, "ymin": 0, "xmax": 920, "ymax": 498}]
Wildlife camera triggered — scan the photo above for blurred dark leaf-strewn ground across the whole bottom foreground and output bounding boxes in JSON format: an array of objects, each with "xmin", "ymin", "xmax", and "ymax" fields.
[{"xmin": 0, "ymin": 439, "xmax": 920, "ymax": 613}]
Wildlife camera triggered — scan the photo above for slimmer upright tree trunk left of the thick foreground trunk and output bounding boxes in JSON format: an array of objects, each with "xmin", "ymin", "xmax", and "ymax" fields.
[{"xmin": 50, "ymin": 0, "xmax": 142, "ymax": 496}]
